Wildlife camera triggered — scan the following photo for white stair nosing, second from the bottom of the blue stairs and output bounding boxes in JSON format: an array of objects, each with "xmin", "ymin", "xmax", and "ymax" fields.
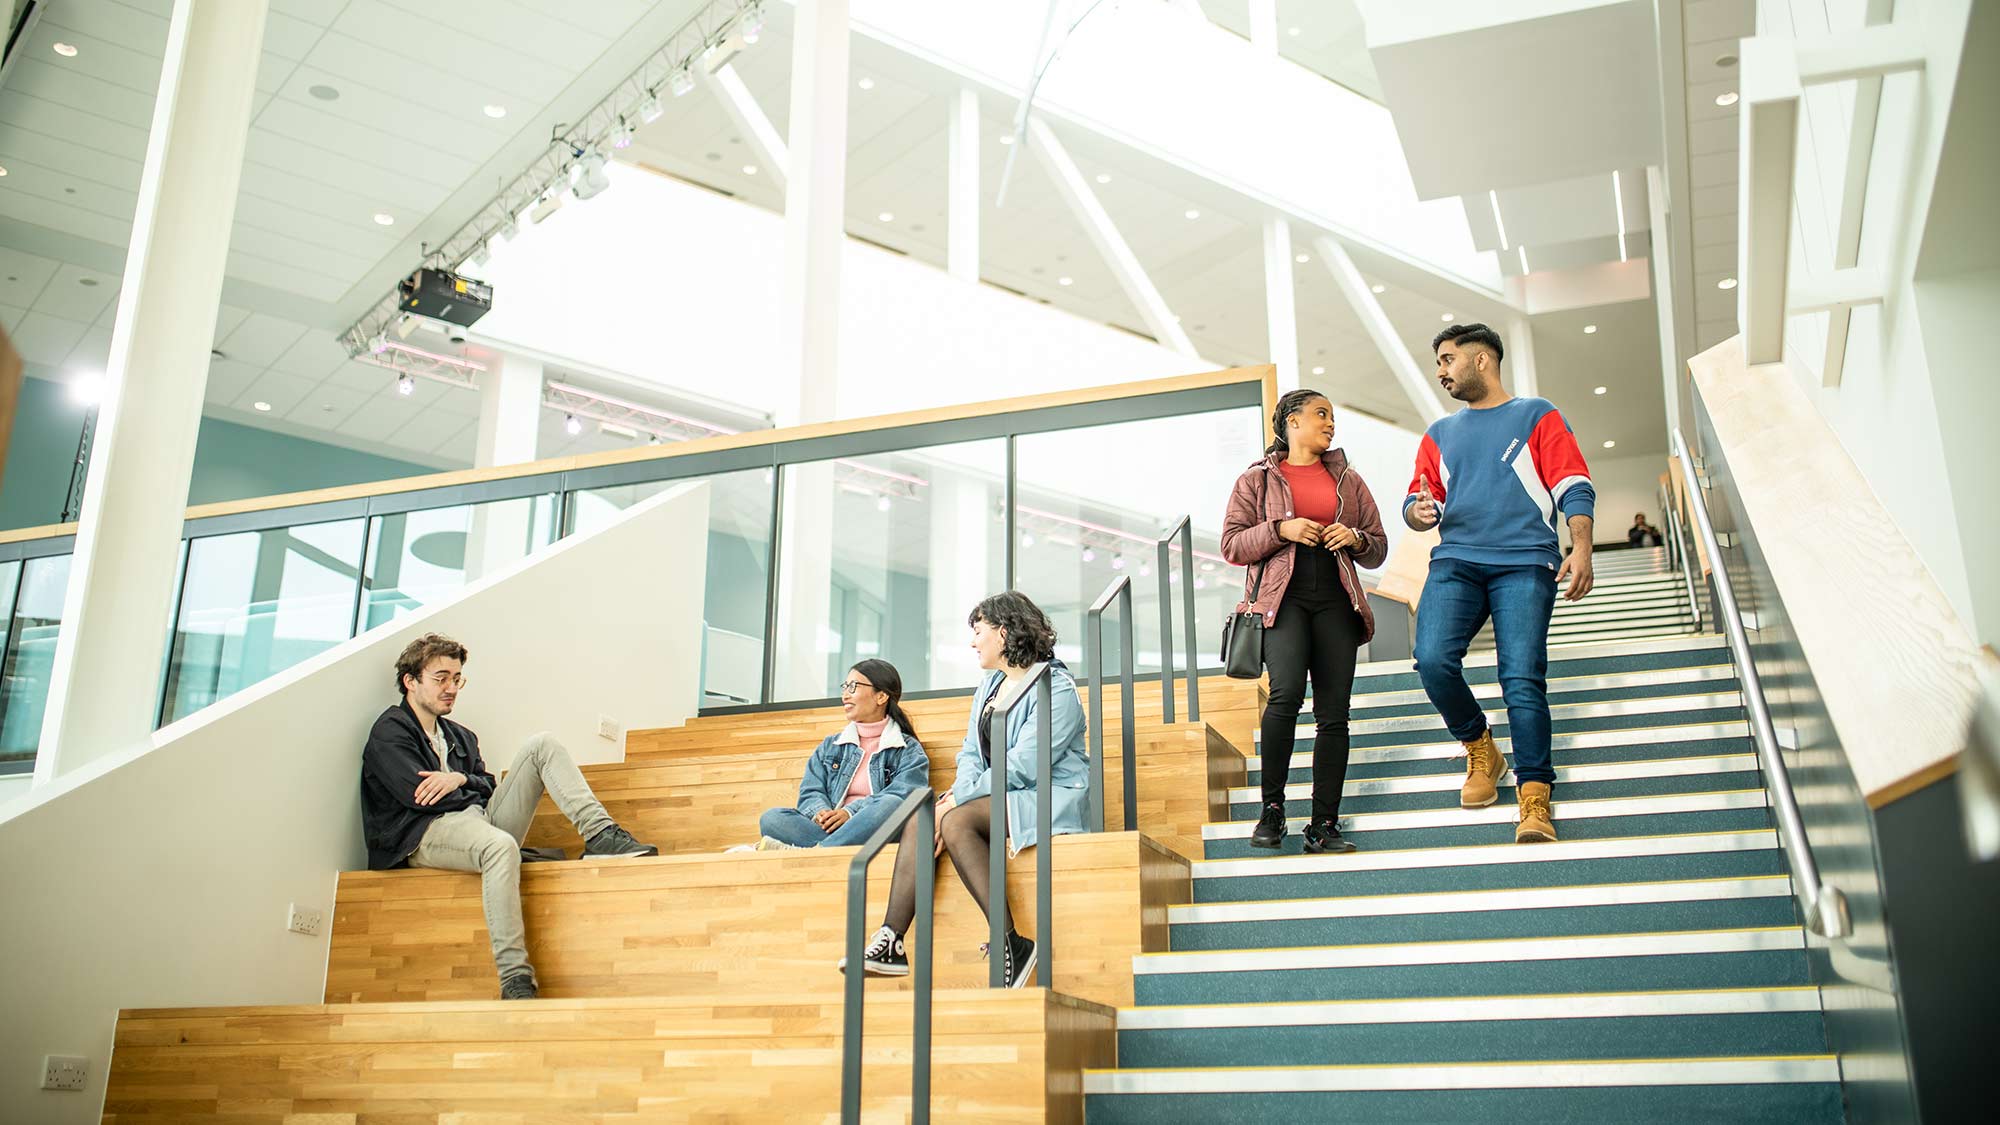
[{"xmin": 1118, "ymin": 985, "xmax": 1822, "ymax": 1031}]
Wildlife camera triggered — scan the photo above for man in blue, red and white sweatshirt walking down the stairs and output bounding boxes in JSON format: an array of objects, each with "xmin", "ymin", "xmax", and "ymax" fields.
[{"xmin": 1402, "ymin": 324, "xmax": 1596, "ymax": 843}]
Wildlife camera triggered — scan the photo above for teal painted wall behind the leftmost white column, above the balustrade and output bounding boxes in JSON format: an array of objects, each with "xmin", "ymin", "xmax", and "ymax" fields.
[{"xmin": 0, "ymin": 378, "xmax": 436, "ymax": 528}]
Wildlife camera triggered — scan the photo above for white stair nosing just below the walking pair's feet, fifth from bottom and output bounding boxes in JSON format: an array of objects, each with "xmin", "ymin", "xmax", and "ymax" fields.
[{"xmin": 1190, "ymin": 829, "xmax": 1778, "ymax": 879}]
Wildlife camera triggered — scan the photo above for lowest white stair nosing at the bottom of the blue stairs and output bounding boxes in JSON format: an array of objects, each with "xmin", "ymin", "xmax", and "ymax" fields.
[{"xmin": 1084, "ymin": 1055, "xmax": 1840, "ymax": 1095}]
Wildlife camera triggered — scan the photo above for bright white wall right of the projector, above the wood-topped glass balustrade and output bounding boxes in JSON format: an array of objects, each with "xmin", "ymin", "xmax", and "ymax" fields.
[{"xmin": 478, "ymin": 164, "xmax": 1216, "ymax": 418}]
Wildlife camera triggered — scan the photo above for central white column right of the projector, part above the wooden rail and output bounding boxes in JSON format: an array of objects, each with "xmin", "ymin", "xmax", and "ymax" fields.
[{"xmin": 776, "ymin": 0, "xmax": 848, "ymax": 426}]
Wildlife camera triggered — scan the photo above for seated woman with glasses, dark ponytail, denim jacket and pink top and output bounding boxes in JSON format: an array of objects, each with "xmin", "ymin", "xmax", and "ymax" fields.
[{"xmin": 744, "ymin": 661, "xmax": 930, "ymax": 851}]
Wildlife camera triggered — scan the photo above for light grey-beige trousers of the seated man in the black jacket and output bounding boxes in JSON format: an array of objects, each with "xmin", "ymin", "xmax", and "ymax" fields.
[{"xmin": 410, "ymin": 731, "xmax": 612, "ymax": 979}]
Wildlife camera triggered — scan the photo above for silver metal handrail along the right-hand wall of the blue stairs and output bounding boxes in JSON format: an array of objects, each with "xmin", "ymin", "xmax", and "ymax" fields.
[{"xmin": 1674, "ymin": 428, "xmax": 1854, "ymax": 937}]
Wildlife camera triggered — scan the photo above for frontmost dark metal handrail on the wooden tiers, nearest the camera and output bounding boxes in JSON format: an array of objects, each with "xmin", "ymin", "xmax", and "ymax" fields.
[{"xmin": 840, "ymin": 785, "xmax": 938, "ymax": 1125}]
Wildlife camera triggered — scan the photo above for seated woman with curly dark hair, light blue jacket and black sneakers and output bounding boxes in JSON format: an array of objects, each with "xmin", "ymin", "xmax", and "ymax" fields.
[{"xmin": 840, "ymin": 591, "xmax": 1090, "ymax": 989}]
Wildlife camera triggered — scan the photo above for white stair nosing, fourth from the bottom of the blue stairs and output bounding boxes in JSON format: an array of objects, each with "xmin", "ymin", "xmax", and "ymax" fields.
[{"xmin": 1166, "ymin": 875, "xmax": 1792, "ymax": 925}]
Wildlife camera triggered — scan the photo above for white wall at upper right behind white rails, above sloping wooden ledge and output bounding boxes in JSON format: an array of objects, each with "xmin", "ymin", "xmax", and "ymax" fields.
[{"xmin": 1758, "ymin": 0, "xmax": 1994, "ymax": 637}]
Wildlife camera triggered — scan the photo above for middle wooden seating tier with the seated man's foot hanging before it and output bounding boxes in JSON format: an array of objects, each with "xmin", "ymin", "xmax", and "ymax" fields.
[{"xmin": 326, "ymin": 833, "xmax": 1192, "ymax": 1005}]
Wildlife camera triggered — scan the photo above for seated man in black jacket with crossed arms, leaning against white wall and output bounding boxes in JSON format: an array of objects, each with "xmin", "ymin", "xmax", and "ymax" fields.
[{"xmin": 362, "ymin": 633, "xmax": 660, "ymax": 1001}]
